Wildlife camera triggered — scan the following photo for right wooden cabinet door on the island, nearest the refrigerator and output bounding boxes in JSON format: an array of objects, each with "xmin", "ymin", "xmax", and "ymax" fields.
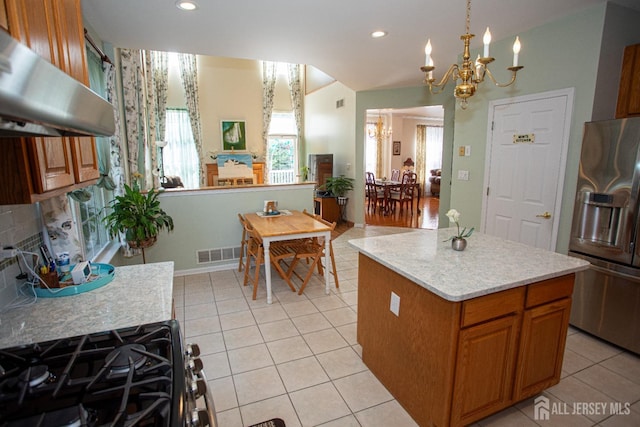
[{"xmin": 514, "ymin": 298, "xmax": 571, "ymax": 401}]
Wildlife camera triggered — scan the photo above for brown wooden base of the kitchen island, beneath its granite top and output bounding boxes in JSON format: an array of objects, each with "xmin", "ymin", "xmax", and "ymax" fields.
[{"xmin": 357, "ymin": 254, "xmax": 574, "ymax": 426}]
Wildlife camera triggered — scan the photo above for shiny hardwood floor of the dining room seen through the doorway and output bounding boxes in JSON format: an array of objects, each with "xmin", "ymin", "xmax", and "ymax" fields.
[{"xmin": 365, "ymin": 196, "xmax": 440, "ymax": 229}]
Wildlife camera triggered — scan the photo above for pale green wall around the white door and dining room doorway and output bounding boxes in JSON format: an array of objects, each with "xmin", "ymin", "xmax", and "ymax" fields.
[{"xmin": 356, "ymin": 4, "xmax": 606, "ymax": 252}]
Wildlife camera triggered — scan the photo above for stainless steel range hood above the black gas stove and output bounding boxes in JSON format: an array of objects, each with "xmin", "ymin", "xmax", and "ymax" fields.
[{"xmin": 0, "ymin": 29, "xmax": 115, "ymax": 137}]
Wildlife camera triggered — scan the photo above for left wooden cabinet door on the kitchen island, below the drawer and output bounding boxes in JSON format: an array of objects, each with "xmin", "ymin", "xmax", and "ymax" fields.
[{"xmin": 451, "ymin": 314, "xmax": 521, "ymax": 426}]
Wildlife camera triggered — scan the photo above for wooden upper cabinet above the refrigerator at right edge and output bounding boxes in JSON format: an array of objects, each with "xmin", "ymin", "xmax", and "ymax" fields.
[{"xmin": 616, "ymin": 44, "xmax": 640, "ymax": 119}]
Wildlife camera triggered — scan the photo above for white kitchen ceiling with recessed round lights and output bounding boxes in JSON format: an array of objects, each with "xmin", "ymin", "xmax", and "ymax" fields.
[{"xmin": 82, "ymin": 0, "xmax": 640, "ymax": 91}]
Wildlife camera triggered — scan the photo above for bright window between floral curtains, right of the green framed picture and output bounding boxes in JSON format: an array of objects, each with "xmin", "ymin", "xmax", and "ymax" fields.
[{"xmin": 267, "ymin": 111, "xmax": 298, "ymax": 184}]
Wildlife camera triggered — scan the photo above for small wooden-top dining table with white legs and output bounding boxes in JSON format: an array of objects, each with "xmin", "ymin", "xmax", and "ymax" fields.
[{"xmin": 244, "ymin": 211, "xmax": 331, "ymax": 304}]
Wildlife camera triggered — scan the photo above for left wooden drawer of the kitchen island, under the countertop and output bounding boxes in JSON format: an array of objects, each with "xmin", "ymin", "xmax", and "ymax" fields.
[{"xmin": 461, "ymin": 286, "xmax": 526, "ymax": 328}]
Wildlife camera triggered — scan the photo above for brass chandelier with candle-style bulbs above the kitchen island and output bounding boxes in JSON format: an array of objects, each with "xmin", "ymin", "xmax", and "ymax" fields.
[{"xmin": 420, "ymin": 0, "xmax": 523, "ymax": 109}]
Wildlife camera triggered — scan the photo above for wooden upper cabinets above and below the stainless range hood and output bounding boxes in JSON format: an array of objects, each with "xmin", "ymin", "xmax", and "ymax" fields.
[{"xmin": 0, "ymin": 0, "xmax": 100, "ymax": 204}]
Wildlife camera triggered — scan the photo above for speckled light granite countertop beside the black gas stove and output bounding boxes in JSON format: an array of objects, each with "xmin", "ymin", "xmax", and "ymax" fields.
[{"xmin": 0, "ymin": 262, "xmax": 173, "ymax": 348}]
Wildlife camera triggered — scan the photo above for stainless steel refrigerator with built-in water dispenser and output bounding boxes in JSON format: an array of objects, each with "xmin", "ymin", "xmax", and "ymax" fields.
[{"xmin": 569, "ymin": 118, "xmax": 640, "ymax": 353}]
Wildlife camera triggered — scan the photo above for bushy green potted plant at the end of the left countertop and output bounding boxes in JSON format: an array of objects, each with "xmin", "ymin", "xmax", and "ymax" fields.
[{"xmin": 104, "ymin": 184, "xmax": 173, "ymax": 258}]
